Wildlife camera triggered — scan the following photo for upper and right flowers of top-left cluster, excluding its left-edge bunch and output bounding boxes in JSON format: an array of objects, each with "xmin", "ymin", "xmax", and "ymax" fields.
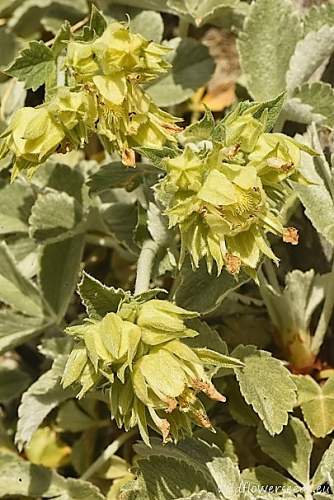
[{"xmin": 65, "ymin": 22, "xmax": 180, "ymax": 165}]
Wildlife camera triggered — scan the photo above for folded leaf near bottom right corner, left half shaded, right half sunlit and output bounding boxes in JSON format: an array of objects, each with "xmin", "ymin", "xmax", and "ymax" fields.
[{"xmin": 257, "ymin": 417, "xmax": 312, "ymax": 485}]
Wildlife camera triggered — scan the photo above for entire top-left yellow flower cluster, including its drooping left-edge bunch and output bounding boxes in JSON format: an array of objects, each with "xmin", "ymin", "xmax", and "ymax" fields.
[{"xmin": 0, "ymin": 22, "xmax": 180, "ymax": 178}]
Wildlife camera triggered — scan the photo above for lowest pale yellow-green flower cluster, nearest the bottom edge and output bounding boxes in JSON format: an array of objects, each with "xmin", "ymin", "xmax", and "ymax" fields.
[{"xmin": 62, "ymin": 299, "xmax": 230, "ymax": 442}]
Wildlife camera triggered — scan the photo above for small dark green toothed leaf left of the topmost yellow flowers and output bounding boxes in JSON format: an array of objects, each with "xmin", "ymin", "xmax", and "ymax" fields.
[{"xmin": 6, "ymin": 40, "xmax": 56, "ymax": 90}]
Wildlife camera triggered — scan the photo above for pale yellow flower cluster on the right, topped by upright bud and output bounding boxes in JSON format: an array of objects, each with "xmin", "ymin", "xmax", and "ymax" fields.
[{"xmin": 156, "ymin": 108, "xmax": 314, "ymax": 277}]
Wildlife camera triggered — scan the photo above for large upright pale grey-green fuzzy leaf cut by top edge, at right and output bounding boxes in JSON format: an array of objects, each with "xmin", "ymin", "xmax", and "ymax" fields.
[{"xmin": 238, "ymin": 0, "xmax": 302, "ymax": 101}]
